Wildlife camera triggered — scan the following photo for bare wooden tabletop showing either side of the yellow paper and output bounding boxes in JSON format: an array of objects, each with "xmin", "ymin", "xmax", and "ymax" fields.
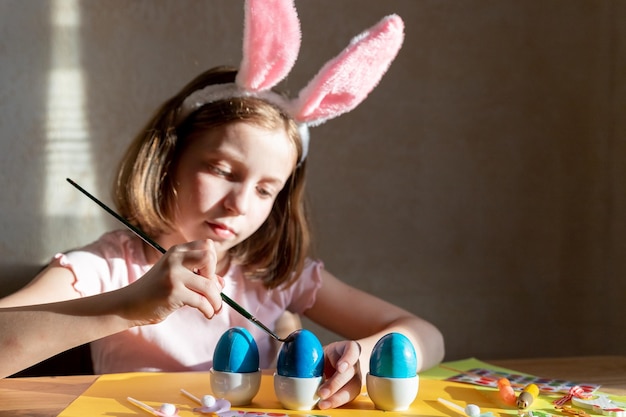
[{"xmin": 0, "ymin": 356, "xmax": 626, "ymax": 417}]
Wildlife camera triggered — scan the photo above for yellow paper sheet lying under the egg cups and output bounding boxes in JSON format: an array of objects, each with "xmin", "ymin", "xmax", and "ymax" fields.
[{"xmin": 60, "ymin": 359, "xmax": 626, "ymax": 417}]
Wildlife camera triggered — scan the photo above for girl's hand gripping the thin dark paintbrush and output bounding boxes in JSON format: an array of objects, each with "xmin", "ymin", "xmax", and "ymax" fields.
[{"xmin": 119, "ymin": 240, "xmax": 224, "ymax": 326}]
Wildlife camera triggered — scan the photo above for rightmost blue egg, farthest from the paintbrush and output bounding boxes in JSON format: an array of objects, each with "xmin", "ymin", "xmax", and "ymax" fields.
[{"xmin": 370, "ymin": 333, "xmax": 417, "ymax": 378}]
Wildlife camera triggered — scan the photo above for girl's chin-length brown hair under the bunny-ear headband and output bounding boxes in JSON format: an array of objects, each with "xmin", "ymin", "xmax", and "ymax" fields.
[{"xmin": 113, "ymin": 67, "xmax": 310, "ymax": 288}]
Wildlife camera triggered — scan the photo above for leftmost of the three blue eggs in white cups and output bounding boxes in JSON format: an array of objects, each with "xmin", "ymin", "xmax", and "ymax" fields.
[{"xmin": 213, "ymin": 327, "xmax": 259, "ymax": 373}]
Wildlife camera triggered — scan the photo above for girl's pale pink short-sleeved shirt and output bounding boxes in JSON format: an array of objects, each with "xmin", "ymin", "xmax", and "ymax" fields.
[{"xmin": 53, "ymin": 230, "xmax": 323, "ymax": 373}]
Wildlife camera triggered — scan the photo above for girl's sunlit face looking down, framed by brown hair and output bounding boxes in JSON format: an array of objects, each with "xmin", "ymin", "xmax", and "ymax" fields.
[{"xmin": 162, "ymin": 118, "xmax": 297, "ymax": 259}]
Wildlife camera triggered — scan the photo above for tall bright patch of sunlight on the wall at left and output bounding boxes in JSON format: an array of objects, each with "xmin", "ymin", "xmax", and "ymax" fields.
[{"xmin": 43, "ymin": 0, "xmax": 103, "ymax": 251}]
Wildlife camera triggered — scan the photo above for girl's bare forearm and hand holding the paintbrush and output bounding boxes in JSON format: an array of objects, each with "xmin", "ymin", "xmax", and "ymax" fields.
[{"xmin": 0, "ymin": 237, "xmax": 223, "ymax": 378}]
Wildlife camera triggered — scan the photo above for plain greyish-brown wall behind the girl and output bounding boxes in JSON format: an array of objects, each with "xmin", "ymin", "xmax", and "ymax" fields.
[{"xmin": 0, "ymin": 0, "xmax": 626, "ymax": 359}]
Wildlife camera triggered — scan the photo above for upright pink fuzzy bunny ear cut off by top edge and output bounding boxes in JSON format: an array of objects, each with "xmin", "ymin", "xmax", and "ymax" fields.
[{"xmin": 236, "ymin": 0, "xmax": 301, "ymax": 92}]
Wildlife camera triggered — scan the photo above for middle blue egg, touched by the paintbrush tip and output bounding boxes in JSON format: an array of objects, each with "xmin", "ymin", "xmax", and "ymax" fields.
[{"xmin": 276, "ymin": 329, "xmax": 324, "ymax": 378}]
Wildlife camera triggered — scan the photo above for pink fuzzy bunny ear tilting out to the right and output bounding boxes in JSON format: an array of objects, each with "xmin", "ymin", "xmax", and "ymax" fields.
[{"xmin": 292, "ymin": 14, "xmax": 404, "ymax": 126}]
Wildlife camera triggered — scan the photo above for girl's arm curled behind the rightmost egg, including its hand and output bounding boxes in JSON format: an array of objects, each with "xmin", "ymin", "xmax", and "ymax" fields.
[{"xmin": 305, "ymin": 270, "xmax": 444, "ymax": 407}]
